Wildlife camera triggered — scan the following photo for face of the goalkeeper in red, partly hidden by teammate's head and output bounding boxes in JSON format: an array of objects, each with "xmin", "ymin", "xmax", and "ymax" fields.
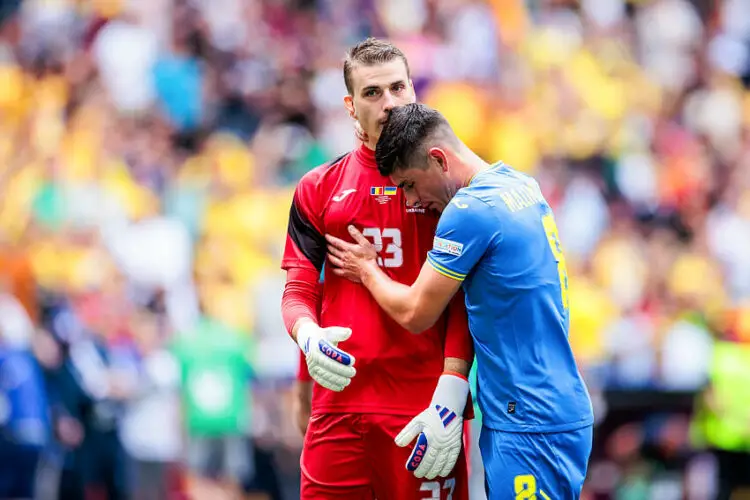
[{"xmin": 344, "ymin": 59, "xmax": 416, "ymax": 149}]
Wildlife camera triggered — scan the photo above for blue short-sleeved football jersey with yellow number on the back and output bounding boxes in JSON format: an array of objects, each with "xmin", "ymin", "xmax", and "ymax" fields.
[{"xmin": 427, "ymin": 163, "xmax": 594, "ymax": 432}]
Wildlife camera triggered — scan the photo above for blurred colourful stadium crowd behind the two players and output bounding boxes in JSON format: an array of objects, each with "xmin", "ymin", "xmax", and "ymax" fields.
[{"xmin": 0, "ymin": 0, "xmax": 750, "ymax": 500}]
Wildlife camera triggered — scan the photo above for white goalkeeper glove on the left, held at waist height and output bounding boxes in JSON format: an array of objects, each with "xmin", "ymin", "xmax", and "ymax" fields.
[{"xmin": 297, "ymin": 322, "xmax": 357, "ymax": 392}]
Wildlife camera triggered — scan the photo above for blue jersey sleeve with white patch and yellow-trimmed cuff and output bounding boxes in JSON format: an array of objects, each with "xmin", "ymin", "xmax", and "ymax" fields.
[{"xmin": 427, "ymin": 192, "xmax": 500, "ymax": 281}]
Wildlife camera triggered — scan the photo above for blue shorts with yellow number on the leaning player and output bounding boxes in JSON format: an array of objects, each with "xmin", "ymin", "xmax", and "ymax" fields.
[{"xmin": 479, "ymin": 426, "xmax": 593, "ymax": 500}]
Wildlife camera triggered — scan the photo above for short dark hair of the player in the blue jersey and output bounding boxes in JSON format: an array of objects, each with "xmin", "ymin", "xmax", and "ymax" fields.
[{"xmin": 375, "ymin": 103, "xmax": 454, "ymax": 177}]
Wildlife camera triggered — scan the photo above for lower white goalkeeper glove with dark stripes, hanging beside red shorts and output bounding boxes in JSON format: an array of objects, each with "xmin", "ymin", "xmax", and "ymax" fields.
[{"xmin": 396, "ymin": 373, "xmax": 469, "ymax": 479}]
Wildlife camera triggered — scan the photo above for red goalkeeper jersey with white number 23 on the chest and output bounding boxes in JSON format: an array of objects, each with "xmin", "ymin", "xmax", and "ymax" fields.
[{"xmin": 281, "ymin": 146, "xmax": 473, "ymax": 415}]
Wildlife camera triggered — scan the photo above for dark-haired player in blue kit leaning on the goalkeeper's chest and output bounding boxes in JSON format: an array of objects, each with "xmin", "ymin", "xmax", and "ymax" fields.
[{"xmin": 328, "ymin": 104, "xmax": 594, "ymax": 500}]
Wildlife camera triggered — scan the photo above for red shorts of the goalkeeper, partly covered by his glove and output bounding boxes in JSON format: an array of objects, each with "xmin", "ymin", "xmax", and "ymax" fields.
[{"xmin": 300, "ymin": 414, "xmax": 469, "ymax": 500}]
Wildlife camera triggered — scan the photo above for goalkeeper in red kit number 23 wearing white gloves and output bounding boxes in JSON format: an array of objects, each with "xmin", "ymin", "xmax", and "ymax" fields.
[{"xmin": 282, "ymin": 39, "xmax": 473, "ymax": 500}]
